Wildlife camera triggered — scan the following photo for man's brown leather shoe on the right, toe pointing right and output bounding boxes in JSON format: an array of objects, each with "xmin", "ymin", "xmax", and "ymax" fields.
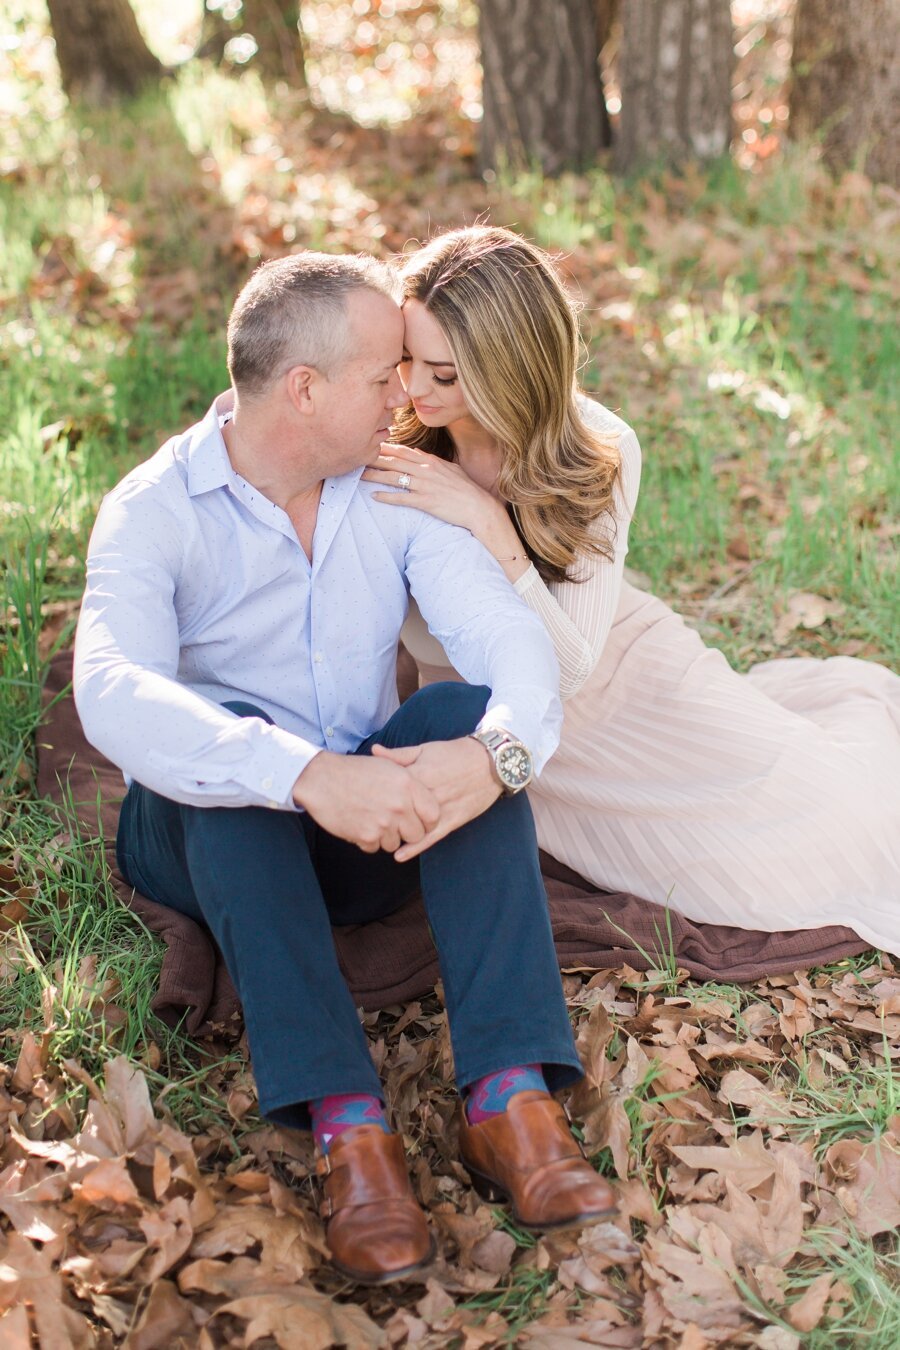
[{"xmin": 459, "ymin": 1089, "xmax": 615, "ymax": 1230}]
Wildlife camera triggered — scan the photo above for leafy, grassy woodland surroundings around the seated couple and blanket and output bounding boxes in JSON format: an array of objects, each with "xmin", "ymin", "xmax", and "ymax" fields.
[{"xmin": 0, "ymin": 0, "xmax": 900, "ymax": 1350}]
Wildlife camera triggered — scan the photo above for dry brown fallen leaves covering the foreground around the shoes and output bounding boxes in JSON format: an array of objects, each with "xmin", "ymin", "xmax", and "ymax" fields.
[{"xmin": 0, "ymin": 963, "xmax": 900, "ymax": 1350}]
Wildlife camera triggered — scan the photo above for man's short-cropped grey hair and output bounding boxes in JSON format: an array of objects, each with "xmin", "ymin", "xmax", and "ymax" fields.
[{"xmin": 228, "ymin": 252, "xmax": 397, "ymax": 397}]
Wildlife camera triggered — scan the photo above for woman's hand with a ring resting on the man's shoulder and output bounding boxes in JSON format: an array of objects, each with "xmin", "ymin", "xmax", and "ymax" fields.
[{"xmin": 363, "ymin": 441, "xmax": 506, "ymax": 543}]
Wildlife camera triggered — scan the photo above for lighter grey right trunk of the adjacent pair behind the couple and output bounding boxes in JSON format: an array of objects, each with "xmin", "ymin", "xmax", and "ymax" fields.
[{"xmin": 617, "ymin": 0, "xmax": 734, "ymax": 170}]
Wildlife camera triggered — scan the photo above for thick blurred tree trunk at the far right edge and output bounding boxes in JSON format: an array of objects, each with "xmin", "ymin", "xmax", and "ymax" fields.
[{"xmin": 791, "ymin": 0, "xmax": 900, "ymax": 188}]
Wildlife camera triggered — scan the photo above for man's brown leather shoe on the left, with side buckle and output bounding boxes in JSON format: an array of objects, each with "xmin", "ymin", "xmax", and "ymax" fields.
[{"xmin": 316, "ymin": 1125, "xmax": 434, "ymax": 1284}]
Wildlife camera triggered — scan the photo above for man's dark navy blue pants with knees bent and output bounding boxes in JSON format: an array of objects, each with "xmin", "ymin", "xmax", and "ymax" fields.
[{"xmin": 117, "ymin": 683, "xmax": 582, "ymax": 1126}]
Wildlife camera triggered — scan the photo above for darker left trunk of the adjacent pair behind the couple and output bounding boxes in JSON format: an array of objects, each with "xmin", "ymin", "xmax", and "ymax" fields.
[{"xmin": 479, "ymin": 0, "xmax": 610, "ymax": 176}]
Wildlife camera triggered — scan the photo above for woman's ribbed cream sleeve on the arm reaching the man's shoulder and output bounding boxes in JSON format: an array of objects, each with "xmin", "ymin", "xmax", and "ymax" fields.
[{"xmin": 515, "ymin": 427, "xmax": 641, "ymax": 699}]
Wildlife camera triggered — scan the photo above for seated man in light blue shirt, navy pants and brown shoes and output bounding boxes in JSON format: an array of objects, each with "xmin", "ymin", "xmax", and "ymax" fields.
[{"xmin": 76, "ymin": 254, "xmax": 620, "ymax": 1283}]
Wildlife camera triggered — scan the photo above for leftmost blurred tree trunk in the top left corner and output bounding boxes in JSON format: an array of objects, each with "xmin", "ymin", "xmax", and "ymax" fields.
[{"xmin": 47, "ymin": 0, "xmax": 163, "ymax": 103}]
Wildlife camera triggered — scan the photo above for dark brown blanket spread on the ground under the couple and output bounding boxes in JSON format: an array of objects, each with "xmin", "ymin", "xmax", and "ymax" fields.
[{"xmin": 38, "ymin": 652, "xmax": 868, "ymax": 1035}]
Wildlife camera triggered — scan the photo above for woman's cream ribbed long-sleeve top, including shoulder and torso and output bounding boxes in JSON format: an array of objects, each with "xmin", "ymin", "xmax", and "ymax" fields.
[{"xmin": 401, "ymin": 397, "xmax": 641, "ymax": 699}]
